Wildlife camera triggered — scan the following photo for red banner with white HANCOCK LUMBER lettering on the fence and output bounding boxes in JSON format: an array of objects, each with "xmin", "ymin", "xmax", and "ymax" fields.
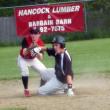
[{"xmin": 15, "ymin": 3, "xmax": 85, "ymax": 36}]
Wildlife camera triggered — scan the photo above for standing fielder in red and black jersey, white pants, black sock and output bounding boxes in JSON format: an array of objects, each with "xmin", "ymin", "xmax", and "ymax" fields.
[{"xmin": 18, "ymin": 28, "xmax": 46, "ymax": 97}]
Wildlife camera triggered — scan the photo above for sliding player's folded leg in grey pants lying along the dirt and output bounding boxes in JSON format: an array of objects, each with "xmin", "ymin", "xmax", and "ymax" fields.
[{"xmin": 38, "ymin": 77, "xmax": 65, "ymax": 95}]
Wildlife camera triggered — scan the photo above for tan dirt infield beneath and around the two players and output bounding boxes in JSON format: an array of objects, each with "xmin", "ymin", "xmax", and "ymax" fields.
[{"xmin": 0, "ymin": 76, "xmax": 110, "ymax": 110}]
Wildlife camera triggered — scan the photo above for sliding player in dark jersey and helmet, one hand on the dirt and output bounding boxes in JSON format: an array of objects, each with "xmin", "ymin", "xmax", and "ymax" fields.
[{"xmin": 38, "ymin": 36, "xmax": 74, "ymax": 96}]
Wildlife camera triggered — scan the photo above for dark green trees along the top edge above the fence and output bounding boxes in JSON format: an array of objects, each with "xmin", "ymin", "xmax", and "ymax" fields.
[{"xmin": 0, "ymin": 0, "xmax": 110, "ymax": 16}]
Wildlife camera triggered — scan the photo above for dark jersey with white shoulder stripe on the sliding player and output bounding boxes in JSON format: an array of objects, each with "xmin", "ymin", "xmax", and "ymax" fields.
[{"xmin": 47, "ymin": 48, "xmax": 73, "ymax": 83}]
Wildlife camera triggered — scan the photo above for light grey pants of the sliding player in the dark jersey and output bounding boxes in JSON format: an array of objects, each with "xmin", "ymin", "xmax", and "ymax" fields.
[{"xmin": 37, "ymin": 68, "xmax": 67, "ymax": 95}]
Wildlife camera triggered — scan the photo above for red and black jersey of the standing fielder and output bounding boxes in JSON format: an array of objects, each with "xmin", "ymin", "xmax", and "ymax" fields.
[{"xmin": 20, "ymin": 36, "xmax": 44, "ymax": 59}]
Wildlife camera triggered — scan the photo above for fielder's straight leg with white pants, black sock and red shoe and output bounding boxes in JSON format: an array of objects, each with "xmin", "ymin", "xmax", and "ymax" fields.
[{"xmin": 18, "ymin": 56, "xmax": 30, "ymax": 96}]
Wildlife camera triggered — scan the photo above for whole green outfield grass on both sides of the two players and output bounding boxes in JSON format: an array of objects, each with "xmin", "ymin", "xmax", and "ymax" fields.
[{"xmin": 0, "ymin": 39, "xmax": 110, "ymax": 79}]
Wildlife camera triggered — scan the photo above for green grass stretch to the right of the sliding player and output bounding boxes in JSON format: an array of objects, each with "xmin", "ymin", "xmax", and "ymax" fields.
[{"xmin": 67, "ymin": 39, "xmax": 110, "ymax": 74}]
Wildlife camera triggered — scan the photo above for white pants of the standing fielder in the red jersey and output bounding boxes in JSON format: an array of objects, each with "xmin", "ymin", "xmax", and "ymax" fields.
[{"xmin": 18, "ymin": 55, "xmax": 55, "ymax": 81}]
